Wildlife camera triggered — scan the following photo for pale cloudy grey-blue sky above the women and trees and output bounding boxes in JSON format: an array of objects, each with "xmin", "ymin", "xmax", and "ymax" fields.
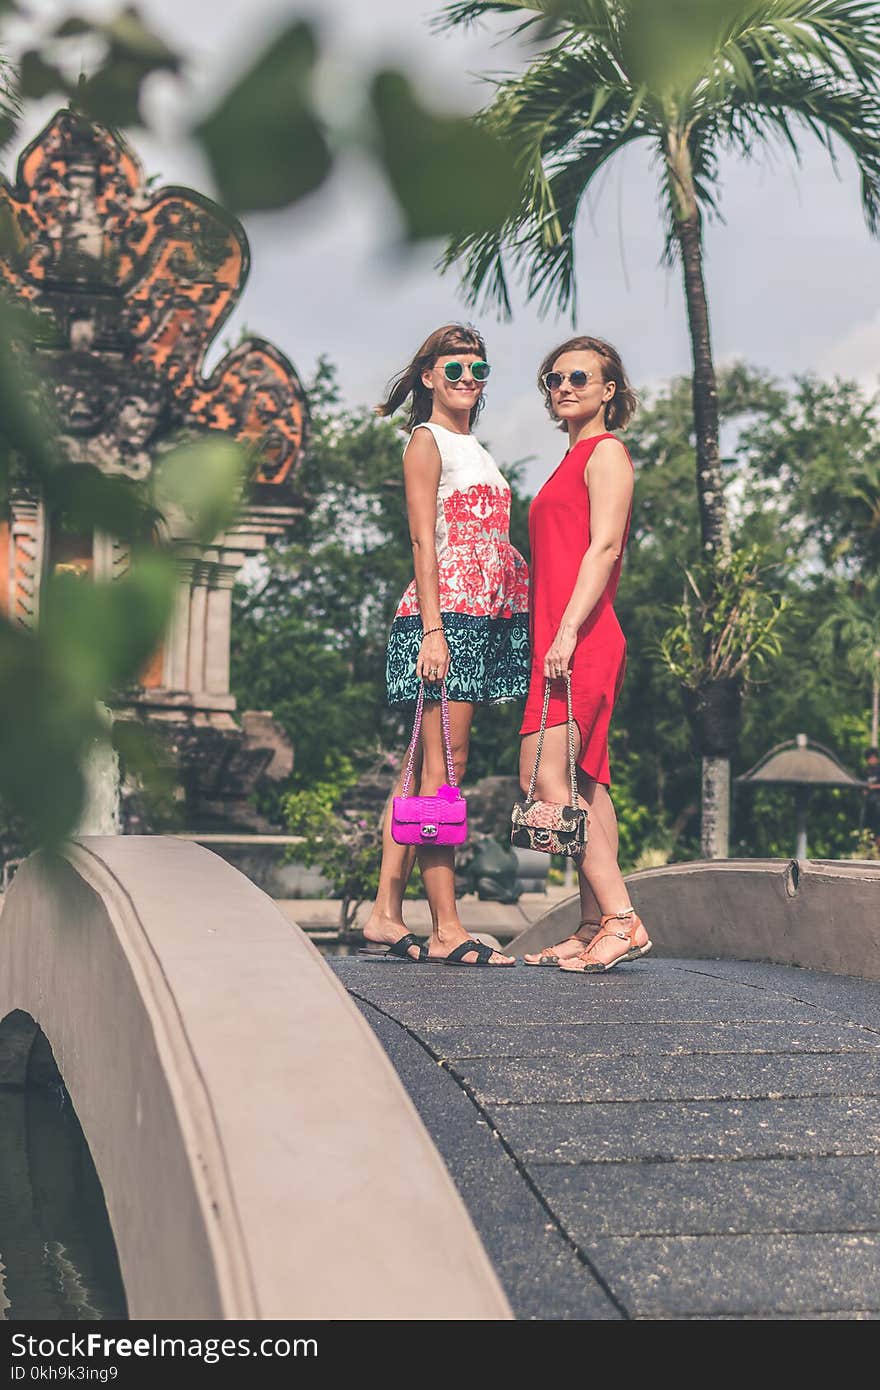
[{"xmin": 4, "ymin": 0, "xmax": 880, "ymax": 488}]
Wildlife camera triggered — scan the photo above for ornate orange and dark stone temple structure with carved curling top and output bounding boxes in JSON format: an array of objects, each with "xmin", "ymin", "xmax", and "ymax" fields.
[{"xmin": 0, "ymin": 110, "xmax": 307, "ymax": 828}]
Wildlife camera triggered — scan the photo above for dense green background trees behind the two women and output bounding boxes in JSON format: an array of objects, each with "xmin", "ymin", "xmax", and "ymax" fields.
[{"xmin": 232, "ymin": 363, "xmax": 880, "ymax": 872}]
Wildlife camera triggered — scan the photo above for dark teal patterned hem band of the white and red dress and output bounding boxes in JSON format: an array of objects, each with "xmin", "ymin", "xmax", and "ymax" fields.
[{"xmin": 385, "ymin": 613, "xmax": 531, "ymax": 705}]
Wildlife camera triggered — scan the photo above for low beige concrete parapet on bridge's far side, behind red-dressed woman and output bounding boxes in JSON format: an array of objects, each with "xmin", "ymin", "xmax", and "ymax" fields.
[{"xmin": 507, "ymin": 859, "xmax": 880, "ymax": 980}]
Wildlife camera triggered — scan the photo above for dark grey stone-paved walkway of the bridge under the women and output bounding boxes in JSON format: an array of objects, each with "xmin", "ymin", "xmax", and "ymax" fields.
[{"xmin": 331, "ymin": 956, "xmax": 880, "ymax": 1319}]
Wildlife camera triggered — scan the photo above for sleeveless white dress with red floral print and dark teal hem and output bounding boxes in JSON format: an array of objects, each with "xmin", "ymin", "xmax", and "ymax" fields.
[{"xmin": 385, "ymin": 423, "xmax": 530, "ymax": 705}]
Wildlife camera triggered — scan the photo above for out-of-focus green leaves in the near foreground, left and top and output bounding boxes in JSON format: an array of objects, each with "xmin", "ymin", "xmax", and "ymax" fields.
[{"xmin": 0, "ymin": 0, "xmax": 514, "ymax": 844}]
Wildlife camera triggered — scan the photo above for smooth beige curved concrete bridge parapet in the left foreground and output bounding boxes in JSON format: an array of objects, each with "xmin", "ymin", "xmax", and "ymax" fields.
[{"xmin": 0, "ymin": 835, "xmax": 510, "ymax": 1319}]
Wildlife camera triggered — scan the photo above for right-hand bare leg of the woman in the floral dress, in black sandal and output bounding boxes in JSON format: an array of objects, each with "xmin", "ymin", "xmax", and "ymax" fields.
[{"xmin": 417, "ymin": 701, "xmax": 514, "ymax": 966}]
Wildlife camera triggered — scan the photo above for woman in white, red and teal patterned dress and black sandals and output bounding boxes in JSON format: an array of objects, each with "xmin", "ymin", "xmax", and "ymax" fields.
[{"xmin": 364, "ymin": 324, "xmax": 530, "ymax": 966}]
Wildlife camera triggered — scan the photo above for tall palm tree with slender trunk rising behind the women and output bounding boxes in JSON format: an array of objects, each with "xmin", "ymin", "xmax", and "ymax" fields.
[{"xmin": 438, "ymin": 0, "xmax": 880, "ymax": 858}]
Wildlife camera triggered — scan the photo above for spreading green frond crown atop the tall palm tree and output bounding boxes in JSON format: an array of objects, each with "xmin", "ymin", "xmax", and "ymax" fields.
[{"xmin": 443, "ymin": 0, "xmax": 880, "ymax": 313}]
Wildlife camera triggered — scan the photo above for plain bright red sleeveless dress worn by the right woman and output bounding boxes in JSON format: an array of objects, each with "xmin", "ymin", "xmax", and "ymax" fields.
[{"xmin": 520, "ymin": 434, "xmax": 633, "ymax": 787}]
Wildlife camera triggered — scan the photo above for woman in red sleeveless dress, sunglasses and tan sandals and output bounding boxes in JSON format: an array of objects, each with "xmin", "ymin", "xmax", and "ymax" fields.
[{"xmin": 520, "ymin": 338, "xmax": 651, "ymax": 974}]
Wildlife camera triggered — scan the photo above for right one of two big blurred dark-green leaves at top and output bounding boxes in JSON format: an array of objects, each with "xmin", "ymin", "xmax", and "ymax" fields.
[{"xmin": 373, "ymin": 72, "xmax": 520, "ymax": 240}]
